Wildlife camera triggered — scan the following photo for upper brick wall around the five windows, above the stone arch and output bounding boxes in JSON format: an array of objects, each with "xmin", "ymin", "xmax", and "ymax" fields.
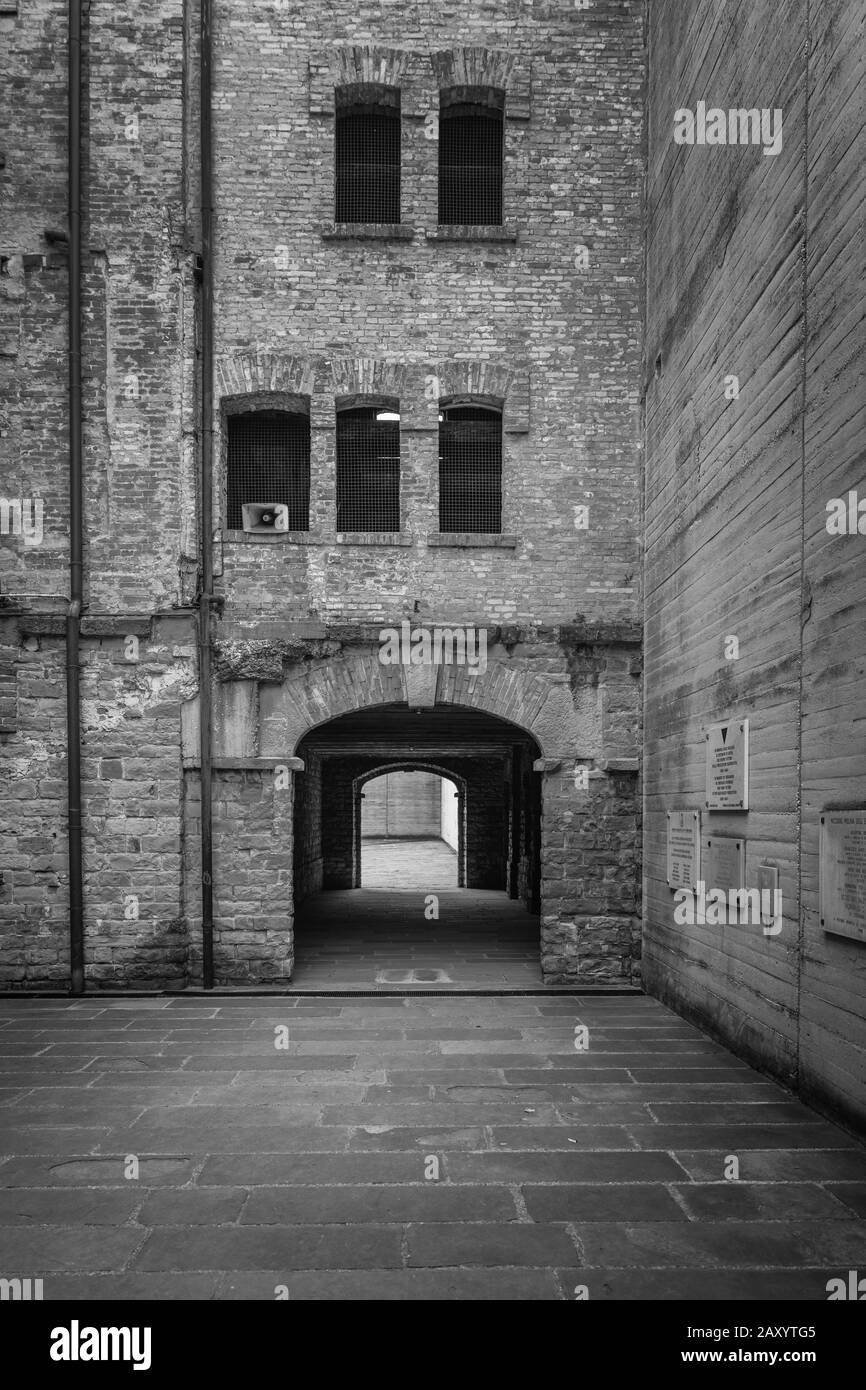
[{"xmin": 209, "ymin": 0, "xmax": 642, "ymax": 621}]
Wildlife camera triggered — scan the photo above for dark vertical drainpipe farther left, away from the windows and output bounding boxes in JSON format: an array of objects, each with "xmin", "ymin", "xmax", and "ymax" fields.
[{"xmin": 67, "ymin": 0, "xmax": 85, "ymax": 994}]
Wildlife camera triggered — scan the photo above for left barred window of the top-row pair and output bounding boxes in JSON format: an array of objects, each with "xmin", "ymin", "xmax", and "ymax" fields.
[{"xmin": 334, "ymin": 85, "xmax": 400, "ymax": 222}]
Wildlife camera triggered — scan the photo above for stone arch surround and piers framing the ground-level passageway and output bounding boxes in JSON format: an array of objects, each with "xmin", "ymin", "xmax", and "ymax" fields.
[{"xmin": 189, "ymin": 627, "xmax": 639, "ymax": 983}]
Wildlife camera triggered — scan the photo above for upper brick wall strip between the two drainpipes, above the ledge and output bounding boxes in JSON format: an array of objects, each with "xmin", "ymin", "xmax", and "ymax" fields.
[{"xmin": 83, "ymin": 0, "xmax": 197, "ymax": 613}]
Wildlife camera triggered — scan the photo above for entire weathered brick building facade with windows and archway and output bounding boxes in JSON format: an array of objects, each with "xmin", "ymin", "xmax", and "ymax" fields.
[{"xmin": 0, "ymin": 0, "xmax": 644, "ymax": 988}]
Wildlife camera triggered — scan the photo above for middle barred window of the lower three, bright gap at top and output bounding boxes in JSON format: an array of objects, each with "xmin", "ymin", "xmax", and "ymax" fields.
[{"xmin": 336, "ymin": 400, "xmax": 400, "ymax": 531}]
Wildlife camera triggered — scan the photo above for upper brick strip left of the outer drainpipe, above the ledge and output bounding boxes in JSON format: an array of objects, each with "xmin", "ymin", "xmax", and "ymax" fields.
[{"xmin": 0, "ymin": 0, "xmax": 68, "ymax": 606}]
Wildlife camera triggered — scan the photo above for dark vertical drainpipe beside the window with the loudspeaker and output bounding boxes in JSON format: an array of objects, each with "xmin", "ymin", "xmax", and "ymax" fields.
[{"xmin": 199, "ymin": 0, "xmax": 214, "ymax": 990}]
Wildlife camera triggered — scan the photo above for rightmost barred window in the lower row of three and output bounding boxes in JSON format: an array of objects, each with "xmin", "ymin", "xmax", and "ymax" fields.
[{"xmin": 439, "ymin": 403, "xmax": 502, "ymax": 532}]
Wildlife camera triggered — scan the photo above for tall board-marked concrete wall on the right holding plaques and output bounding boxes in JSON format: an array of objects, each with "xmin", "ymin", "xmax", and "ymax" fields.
[{"xmin": 645, "ymin": 0, "xmax": 866, "ymax": 1122}]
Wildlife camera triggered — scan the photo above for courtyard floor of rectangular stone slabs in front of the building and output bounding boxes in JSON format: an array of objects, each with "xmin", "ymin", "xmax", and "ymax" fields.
[{"xmin": 0, "ymin": 995, "xmax": 866, "ymax": 1301}]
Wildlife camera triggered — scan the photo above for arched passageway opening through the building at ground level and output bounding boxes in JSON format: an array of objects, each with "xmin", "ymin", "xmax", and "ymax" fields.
[{"xmin": 293, "ymin": 705, "xmax": 541, "ymax": 988}]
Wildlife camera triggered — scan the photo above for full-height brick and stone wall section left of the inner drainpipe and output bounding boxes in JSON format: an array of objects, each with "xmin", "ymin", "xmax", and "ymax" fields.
[{"xmin": 0, "ymin": 0, "xmax": 196, "ymax": 988}]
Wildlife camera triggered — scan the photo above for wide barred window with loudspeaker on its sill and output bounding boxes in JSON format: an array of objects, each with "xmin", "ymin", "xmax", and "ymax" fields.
[{"xmin": 225, "ymin": 410, "xmax": 310, "ymax": 531}]
